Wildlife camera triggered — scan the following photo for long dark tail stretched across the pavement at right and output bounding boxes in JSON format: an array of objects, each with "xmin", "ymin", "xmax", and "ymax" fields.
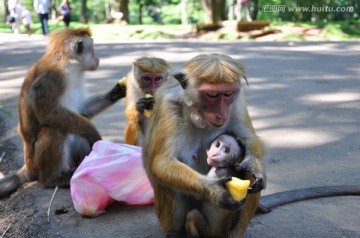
[{"xmin": 256, "ymin": 185, "xmax": 360, "ymax": 213}]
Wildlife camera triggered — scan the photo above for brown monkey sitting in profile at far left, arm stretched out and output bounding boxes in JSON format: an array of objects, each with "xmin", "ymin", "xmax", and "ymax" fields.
[{"xmin": 0, "ymin": 28, "xmax": 126, "ymax": 197}]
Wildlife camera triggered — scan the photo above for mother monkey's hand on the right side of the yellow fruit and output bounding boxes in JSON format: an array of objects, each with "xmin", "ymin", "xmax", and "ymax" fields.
[{"xmin": 235, "ymin": 155, "xmax": 266, "ymax": 193}]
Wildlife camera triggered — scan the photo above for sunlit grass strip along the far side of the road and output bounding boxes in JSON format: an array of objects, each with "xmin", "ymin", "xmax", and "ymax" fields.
[{"xmin": 0, "ymin": 21, "xmax": 360, "ymax": 41}]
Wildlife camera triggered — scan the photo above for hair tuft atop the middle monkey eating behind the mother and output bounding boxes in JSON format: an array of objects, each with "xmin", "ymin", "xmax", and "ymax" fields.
[{"xmin": 133, "ymin": 57, "xmax": 170, "ymax": 73}]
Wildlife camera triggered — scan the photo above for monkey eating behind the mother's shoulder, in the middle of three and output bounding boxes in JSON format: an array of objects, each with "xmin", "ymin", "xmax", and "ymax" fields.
[{"xmin": 124, "ymin": 57, "xmax": 172, "ymax": 146}]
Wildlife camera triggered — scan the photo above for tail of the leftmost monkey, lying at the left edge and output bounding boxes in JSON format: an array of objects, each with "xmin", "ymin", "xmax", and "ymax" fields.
[{"xmin": 0, "ymin": 166, "xmax": 34, "ymax": 198}]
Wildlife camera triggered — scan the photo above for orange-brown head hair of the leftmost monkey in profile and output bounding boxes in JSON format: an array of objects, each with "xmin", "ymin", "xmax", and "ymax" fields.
[{"xmin": 47, "ymin": 28, "xmax": 92, "ymax": 57}]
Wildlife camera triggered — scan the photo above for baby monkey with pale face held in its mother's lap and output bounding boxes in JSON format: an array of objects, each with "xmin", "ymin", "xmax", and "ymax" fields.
[{"xmin": 185, "ymin": 134, "xmax": 245, "ymax": 237}]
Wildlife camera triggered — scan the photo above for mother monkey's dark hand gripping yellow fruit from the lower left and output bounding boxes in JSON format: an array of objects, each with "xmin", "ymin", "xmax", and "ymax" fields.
[{"xmin": 210, "ymin": 176, "xmax": 245, "ymax": 210}]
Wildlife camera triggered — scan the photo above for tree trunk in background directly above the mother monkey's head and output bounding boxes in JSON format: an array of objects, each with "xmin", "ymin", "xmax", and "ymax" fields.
[{"xmin": 201, "ymin": 0, "xmax": 226, "ymax": 24}]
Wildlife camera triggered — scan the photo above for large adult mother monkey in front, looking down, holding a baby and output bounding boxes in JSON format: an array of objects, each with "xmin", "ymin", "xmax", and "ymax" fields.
[{"xmin": 143, "ymin": 54, "xmax": 266, "ymax": 237}]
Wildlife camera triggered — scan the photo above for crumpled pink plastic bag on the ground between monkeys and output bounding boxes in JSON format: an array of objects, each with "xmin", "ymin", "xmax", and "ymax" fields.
[{"xmin": 70, "ymin": 141, "xmax": 154, "ymax": 217}]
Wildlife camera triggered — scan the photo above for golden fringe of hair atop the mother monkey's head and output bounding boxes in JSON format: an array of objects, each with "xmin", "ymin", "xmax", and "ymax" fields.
[{"xmin": 184, "ymin": 53, "xmax": 246, "ymax": 83}]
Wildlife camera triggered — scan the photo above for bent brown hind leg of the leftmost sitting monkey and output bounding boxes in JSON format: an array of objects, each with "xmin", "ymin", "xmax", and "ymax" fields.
[{"xmin": 29, "ymin": 127, "xmax": 70, "ymax": 187}]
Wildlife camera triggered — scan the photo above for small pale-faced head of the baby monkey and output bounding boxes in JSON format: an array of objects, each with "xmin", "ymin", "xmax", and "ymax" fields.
[{"xmin": 207, "ymin": 135, "xmax": 241, "ymax": 168}]
